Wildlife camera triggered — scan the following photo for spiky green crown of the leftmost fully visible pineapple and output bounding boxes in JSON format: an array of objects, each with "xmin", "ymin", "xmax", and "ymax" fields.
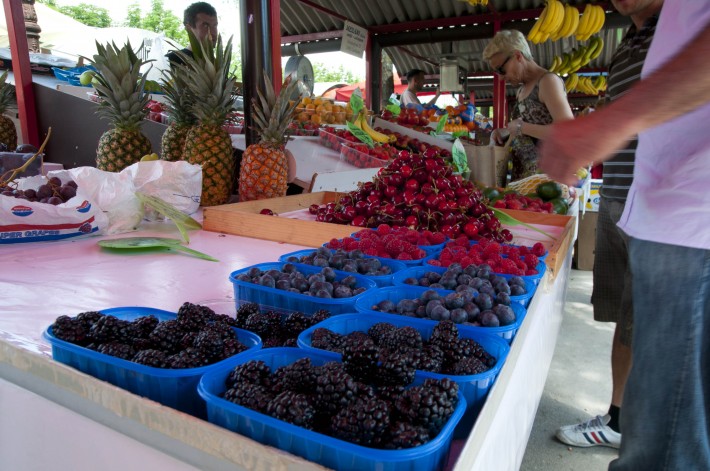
[{"xmin": 87, "ymin": 41, "xmax": 150, "ymax": 131}]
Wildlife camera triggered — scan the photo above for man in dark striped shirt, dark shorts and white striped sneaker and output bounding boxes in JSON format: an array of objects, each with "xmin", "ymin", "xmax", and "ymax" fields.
[{"xmin": 556, "ymin": 0, "xmax": 663, "ymax": 448}]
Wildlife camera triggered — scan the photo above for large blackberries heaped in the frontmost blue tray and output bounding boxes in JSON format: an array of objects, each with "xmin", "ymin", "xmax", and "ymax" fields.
[{"xmin": 222, "ymin": 360, "xmax": 458, "ymax": 450}]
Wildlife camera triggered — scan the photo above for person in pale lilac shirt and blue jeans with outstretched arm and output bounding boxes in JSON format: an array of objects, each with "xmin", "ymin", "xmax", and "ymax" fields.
[{"xmin": 540, "ymin": 0, "xmax": 710, "ymax": 471}]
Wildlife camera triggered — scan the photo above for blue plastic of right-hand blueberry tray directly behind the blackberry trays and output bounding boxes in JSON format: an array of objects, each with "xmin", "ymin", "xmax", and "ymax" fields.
[{"xmin": 355, "ymin": 286, "xmax": 527, "ymax": 343}]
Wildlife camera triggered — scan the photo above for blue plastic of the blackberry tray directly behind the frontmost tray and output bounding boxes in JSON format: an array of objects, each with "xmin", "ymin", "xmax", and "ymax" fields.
[{"xmin": 298, "ymin": 314, "xmax": 510, "ymax": 413}]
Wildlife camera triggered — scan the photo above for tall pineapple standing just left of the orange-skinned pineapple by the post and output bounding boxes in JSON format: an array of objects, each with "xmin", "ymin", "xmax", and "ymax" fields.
[{"xmin": 178, "ymin": 33, "xmax": 234, "ymax": 206}]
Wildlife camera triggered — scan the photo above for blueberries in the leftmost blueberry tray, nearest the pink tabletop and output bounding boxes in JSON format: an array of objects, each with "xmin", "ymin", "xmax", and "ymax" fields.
[{"xmin": 237, "ymin": 263, "xmax": 367, "ymax": 299}]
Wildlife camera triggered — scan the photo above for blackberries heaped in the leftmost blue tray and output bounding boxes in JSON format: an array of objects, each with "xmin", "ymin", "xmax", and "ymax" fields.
[{"xmin": 52, "ymin": 303, "xmax": 248, "ymax": 369}]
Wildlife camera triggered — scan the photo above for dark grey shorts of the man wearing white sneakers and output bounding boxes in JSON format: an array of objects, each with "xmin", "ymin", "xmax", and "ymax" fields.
[{"xmin": 592, "ymin": 197, "xmax": 633, "ymax": 345}]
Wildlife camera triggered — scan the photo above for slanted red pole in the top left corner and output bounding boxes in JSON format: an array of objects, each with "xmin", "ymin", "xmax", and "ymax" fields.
[{"xmin": 3, "ymin": 0, "xmax": 40, "ymax": 147}]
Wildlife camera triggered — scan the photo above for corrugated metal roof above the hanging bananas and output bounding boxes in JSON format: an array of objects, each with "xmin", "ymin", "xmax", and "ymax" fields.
[{"xmin": 281, "ymin": 0, "xmax": 630, "ymax": 103}]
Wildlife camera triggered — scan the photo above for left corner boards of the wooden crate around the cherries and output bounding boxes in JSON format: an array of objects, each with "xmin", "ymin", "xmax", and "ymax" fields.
[{"xmin": 202, "ymin": 191, "xmax": 357, "ymax": 247}]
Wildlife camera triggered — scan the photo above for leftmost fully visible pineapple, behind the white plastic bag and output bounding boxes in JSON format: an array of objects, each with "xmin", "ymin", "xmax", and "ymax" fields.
[{"xmin": 90, "ymin": 42, "xmax": 152, "ymax": 172}]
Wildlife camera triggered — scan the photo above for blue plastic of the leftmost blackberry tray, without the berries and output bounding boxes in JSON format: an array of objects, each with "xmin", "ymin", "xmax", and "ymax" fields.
[{"xmin": 43, "ymin": 307, "xmax": 261, "ymax": 418}]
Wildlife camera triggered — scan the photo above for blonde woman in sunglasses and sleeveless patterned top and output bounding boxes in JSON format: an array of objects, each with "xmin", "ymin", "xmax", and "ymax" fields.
[{"xmin": 483, "ymin": 29, "xmax": 574, "ymax": 181}]
